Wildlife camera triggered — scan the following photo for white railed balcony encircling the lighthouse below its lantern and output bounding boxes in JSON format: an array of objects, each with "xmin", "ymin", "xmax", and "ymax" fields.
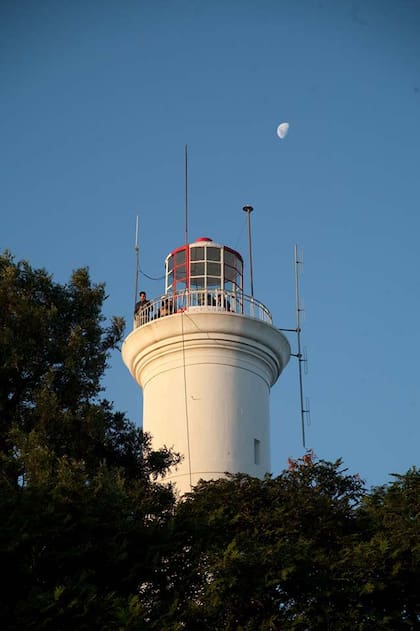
[{"xmin": 134, "ymin": 289, "xmax": 273, "ymax": 329}]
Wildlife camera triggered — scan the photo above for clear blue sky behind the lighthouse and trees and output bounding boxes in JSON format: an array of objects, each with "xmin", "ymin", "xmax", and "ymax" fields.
[{"xmin": 0, "ymin": 0, "xmax": 420, "ymax": 485}]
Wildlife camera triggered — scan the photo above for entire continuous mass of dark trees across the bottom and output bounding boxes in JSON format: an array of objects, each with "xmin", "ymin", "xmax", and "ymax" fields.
[{"xmin": 0, "ymin": 253, "xmax": 420, "ymax": 631}]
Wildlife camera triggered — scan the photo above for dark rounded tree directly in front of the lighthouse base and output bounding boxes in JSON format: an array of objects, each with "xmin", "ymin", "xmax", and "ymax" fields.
[{"xmin": 157, "ymin": 461, "xmax": 363, "ymax": 630}]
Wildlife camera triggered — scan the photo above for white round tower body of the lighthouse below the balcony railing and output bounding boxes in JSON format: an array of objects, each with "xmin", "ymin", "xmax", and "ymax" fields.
[{"xmin": 123, "ymin": 312, "xmax": 290, "ymax": 493}]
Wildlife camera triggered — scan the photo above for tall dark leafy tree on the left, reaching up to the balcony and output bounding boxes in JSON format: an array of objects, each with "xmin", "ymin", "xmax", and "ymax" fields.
[{"xmin": 0, "ymin": 253, "xmax": 177, "ymax": 630}]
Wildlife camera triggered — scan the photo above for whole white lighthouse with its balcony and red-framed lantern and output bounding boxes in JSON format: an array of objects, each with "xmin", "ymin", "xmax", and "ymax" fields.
[{"xmin": 122, "ymin": 238, "xmax": 290, "ymax": 494}]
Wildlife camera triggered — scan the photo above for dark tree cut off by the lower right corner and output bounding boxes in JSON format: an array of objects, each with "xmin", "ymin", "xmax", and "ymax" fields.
[{"xmin": 355, "ymin": 467, "xmax": 420, "ymax": 629}]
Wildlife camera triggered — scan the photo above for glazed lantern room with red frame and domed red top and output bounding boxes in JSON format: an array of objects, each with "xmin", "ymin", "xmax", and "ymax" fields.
[{"xmin": 165, "ymin": 237, "xmax": 243, "ymax": 298}]
